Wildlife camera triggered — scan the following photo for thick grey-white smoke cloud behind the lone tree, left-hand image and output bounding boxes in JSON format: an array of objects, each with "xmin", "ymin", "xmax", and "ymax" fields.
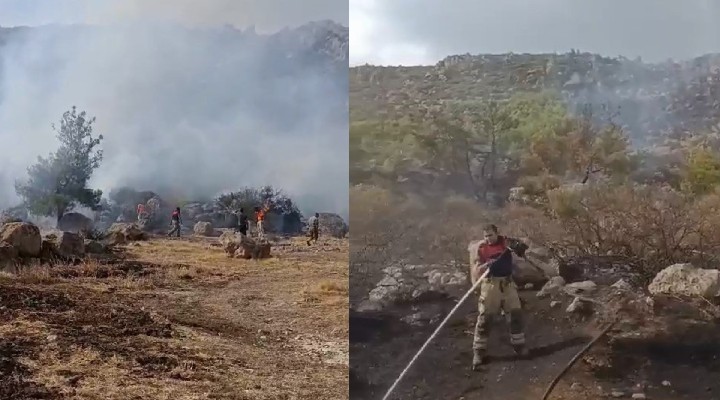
[{"xmin": 0, "ymin": 18, "xmax": 348, "ymax": 216}]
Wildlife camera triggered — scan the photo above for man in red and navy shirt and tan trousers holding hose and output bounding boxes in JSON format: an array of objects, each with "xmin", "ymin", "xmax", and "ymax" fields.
[{"xmin": 471, "ymin": 224, "xmax": 528, "ymax": 370}]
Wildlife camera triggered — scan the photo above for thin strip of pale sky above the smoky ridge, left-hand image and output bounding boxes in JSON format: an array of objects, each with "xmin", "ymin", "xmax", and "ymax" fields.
[{"xmin": 0, "ymin": 0, "xmax": 348, "ymax": 32}]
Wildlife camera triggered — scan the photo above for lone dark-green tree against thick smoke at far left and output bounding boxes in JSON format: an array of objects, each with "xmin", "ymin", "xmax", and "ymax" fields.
[{"xmin": 15, "ymin": 106, "xmax": 103, "ymax": 221}]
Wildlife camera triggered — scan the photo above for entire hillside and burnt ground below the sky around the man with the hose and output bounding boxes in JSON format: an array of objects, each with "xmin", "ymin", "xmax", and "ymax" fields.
[{"xmin": 350, "ymin": 52, "xmax": 720, "ymax": 400}]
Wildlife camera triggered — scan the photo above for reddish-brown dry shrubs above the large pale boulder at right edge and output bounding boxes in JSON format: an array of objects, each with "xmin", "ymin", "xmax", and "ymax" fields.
[{"xmin": 548, "ymin": 184, "xmax": 720, "ymax": 271}]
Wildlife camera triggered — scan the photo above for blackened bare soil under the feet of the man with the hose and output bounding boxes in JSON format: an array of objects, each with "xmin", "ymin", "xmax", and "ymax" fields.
[{"xmin": 350, "ymin": 291, "xmax": 720, "ymax": 400}]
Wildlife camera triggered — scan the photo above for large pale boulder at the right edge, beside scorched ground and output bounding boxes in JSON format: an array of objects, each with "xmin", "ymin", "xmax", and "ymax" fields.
[{"xmin": 648, "ymin": 264, "xmax": 720, "ymax": 298}]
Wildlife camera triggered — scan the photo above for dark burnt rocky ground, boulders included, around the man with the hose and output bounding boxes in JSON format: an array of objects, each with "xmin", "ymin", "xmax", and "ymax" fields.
[{"xmin": 350, "ymin": 252, "xmax": 720, "ymax": 400}]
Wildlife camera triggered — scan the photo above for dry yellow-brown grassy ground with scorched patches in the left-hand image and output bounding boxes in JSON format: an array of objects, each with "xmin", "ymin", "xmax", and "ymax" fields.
[{"xmin": 0, "ymin": 230, "xmax": 348, "ymax": 400}]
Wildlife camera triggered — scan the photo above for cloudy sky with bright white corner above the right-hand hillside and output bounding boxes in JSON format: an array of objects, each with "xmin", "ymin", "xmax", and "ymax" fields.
[{"xmin": 350, "ymin": 0, "xmax": 720, "ymax": 65}]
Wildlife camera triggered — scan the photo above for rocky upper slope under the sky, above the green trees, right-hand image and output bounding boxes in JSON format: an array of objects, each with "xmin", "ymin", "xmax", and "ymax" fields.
[{"xmin": 350, "ymin": 51, "xmax": 720, "ymax": 144}]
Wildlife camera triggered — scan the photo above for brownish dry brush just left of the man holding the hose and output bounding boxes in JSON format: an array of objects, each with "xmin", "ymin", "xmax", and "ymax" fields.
[{"xmin": 350, "ymin": 186, "xmax": 496, "ymax": 302}]
